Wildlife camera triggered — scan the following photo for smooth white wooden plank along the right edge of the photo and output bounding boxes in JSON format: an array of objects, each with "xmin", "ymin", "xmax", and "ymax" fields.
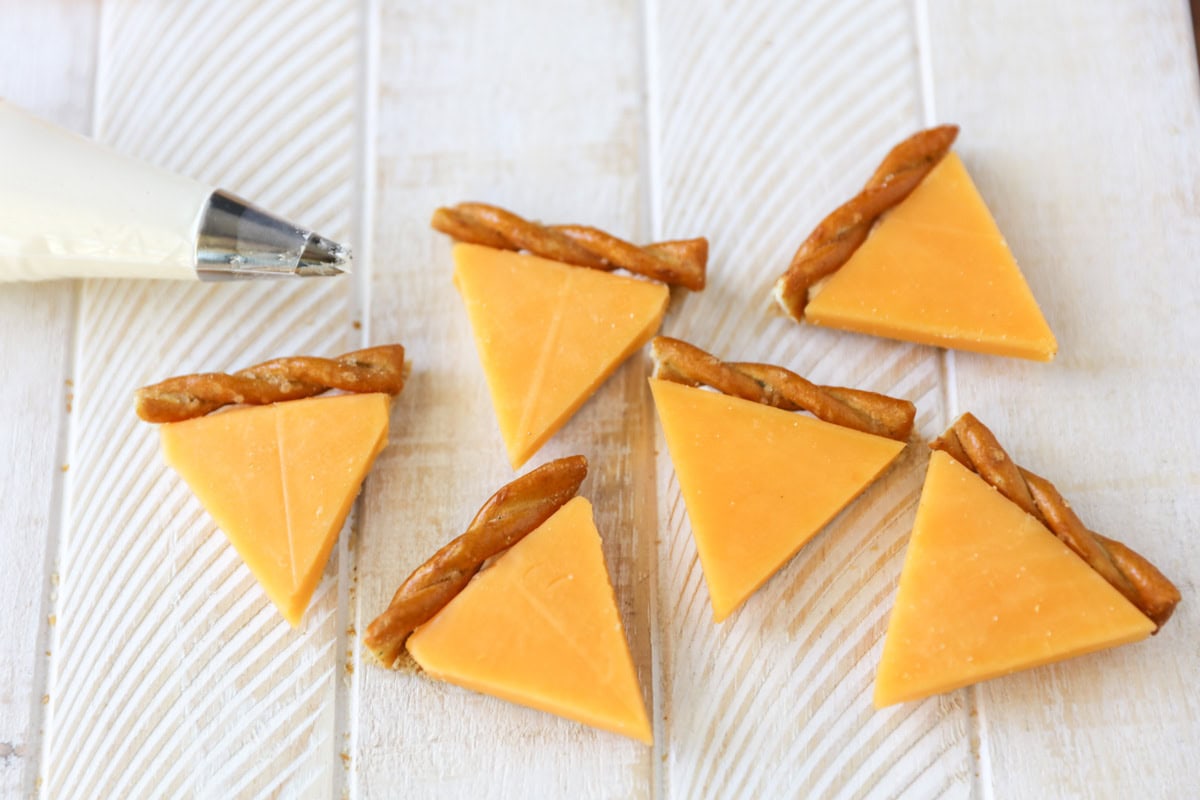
[{"xmin": 930, "ymin": 0, "xmax": 1200, "ymax": 798}]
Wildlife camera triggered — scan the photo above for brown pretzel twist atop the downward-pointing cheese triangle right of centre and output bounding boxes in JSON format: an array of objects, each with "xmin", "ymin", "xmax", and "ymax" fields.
[{"xmin": 650, "ymin": 336, "xmax": 917, "ymax": 441}]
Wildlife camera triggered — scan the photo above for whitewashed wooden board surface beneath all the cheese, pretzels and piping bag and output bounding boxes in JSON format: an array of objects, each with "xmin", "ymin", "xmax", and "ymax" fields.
[{"xmin": 0, "ymin": 0, "xmax": 1200, "ymax": 798}]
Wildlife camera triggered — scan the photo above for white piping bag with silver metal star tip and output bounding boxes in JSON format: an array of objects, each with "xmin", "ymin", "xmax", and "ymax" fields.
[{"xmin": 0, "ymin": 100, "xmax": 352, "ymax": 283}]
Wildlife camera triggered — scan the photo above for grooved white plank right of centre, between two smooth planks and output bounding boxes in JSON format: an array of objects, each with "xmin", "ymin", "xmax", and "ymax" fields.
[{"xmin": 649, "ymin": 0, "xmax": 973, "ymax": 798}]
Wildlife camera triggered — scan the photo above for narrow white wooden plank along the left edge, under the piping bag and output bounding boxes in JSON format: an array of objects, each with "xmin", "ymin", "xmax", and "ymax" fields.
[{"xmin": 0, "ymin": 0, "xmax": 97, "ymax": 796}]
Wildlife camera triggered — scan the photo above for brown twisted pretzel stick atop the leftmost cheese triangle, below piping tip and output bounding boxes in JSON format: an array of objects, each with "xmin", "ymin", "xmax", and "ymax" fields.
[{"xmin": 134, "ymin": 344, "xmax": 408, "ymax": 422}]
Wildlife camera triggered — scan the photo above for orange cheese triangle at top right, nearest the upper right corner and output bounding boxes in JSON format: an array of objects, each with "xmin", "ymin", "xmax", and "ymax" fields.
[{"xmin": 804, "ymin": 152, "xmax": 1058, "ymax": 361}]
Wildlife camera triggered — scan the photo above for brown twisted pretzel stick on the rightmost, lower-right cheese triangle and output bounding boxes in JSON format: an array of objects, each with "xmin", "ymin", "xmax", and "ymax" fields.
[{"xmin": 929, "ymin": 414, "xmax": 1180, "ymax": 627}]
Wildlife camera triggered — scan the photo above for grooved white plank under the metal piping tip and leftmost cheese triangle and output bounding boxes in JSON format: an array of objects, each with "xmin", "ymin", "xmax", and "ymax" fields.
[{"xmin": 43, "ymin": 0, "xmax": 358, "ymax": 796}]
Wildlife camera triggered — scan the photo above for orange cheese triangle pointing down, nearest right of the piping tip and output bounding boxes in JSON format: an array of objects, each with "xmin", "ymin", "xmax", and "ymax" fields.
[{"xmin": 454, "ymin": 245, "xmax": 668, "ymax": 469}]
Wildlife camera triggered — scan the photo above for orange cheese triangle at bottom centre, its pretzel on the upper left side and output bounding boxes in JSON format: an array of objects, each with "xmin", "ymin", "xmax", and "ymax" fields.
[{"xmin": 407, "ymin": 498, "xmax": 652, "ymax": 744}]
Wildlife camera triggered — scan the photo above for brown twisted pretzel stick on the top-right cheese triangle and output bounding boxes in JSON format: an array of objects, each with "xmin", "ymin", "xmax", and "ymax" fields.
[{"xmin": 774, "ymin": 125, "xmax": 959, "ymax": 321}]
